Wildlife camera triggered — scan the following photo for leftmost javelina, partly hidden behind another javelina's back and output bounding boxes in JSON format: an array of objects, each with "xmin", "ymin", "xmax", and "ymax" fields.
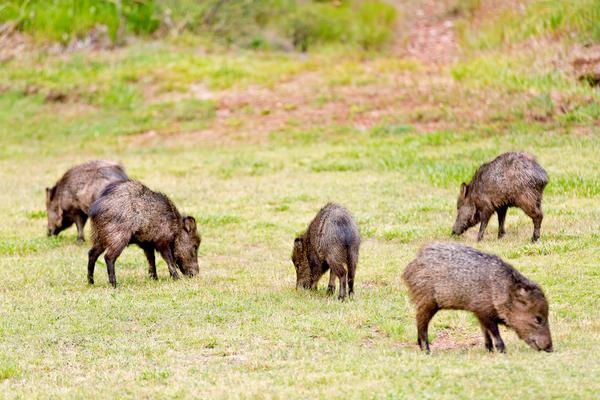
[{"xmin": 46, "ymin": 160, "xmax": 127, "ymax": 242}]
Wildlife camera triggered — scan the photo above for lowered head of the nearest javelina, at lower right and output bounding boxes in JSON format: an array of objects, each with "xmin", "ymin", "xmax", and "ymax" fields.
[{"xmin": 506, "ymin": 284, "xmax": 553, "ymax": 352}]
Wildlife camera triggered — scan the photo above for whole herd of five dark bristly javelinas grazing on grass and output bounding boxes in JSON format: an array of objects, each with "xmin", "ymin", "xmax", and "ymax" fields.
[{"xmin": 46, "ymin": 152, "xmax": 553, "ymax": 353}]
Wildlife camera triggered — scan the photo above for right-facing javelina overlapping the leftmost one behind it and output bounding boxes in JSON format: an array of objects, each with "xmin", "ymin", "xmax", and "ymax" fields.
[{"xmin": 88, "ymin": 181, "xmax": 200, "ymax": 287}]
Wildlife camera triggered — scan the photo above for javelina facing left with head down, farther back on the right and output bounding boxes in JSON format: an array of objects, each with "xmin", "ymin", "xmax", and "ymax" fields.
[{"xmin": 452, "ymin": 153, "xmax": 548, "ymax": 242}]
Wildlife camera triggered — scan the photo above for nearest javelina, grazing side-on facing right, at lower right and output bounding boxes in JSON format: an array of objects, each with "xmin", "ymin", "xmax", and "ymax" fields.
[{"xmin": 402, "ymin": 242, "xmax": 552, "ymax": 352}]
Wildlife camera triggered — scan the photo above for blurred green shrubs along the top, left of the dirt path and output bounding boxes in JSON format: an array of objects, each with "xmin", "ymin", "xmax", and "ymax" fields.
[{"xmin": 0, "ymin": 0, "xmax": 396, "ymax": 50}]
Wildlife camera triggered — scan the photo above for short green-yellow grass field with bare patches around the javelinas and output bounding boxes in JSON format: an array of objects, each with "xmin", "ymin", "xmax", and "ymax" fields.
[{"xmin": 0, "ymin": 1, "xmax": 600, "ymax": 399}]
